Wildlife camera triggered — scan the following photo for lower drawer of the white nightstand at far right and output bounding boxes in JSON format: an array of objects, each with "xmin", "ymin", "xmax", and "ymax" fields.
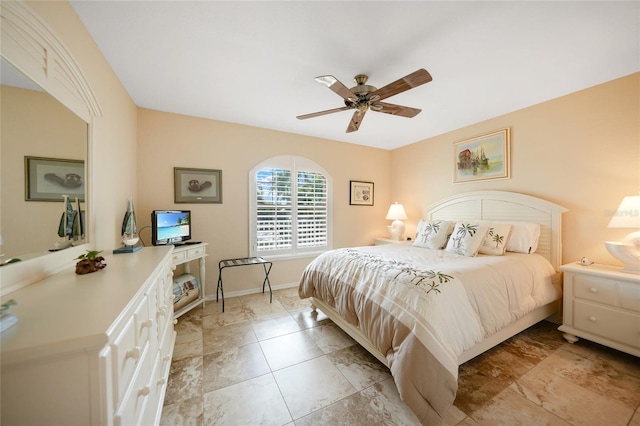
[{"xmin": 573, "ymin": 300, "xmax": 640, "ymax": 348}]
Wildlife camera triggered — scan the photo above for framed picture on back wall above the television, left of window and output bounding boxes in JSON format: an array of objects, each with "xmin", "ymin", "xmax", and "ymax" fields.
[{"xmin": 173, "ymin": 167, "xmax": 222, "ymax": 204}]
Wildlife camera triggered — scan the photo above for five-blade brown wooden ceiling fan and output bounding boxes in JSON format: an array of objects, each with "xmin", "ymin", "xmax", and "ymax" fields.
[{"xmin": 296, "ymin": 68, "xmax": 432, "ymax": 133}]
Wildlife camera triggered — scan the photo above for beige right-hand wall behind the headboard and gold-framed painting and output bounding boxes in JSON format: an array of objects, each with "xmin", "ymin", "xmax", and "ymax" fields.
[{"xmin": 391, "ymin": 73, "xmax": 640, "ymax": 264}]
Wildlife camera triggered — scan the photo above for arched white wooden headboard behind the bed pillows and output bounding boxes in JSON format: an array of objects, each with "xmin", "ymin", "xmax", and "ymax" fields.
[{"xmin": 424, "ymin": 191, "xmax": 567, "ymax": 270}]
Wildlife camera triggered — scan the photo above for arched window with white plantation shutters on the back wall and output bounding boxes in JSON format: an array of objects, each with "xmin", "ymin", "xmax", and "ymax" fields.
[{"xmin": 249, "ymin": 155, "xmax": 332, "ymax": 257}]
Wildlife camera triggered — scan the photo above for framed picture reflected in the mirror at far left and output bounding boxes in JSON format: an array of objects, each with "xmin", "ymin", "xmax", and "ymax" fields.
[{"xmin": 24, "ymin": 157, "xmax": 86, "ymax": 202}]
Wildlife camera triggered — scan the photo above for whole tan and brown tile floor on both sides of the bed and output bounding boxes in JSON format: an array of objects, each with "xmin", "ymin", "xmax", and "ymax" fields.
[{"xmin": 161, "ymin": 288, "xmax": 640, "ymax": 426}]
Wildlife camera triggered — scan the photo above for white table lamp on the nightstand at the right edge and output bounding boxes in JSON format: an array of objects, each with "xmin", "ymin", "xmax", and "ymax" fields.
[{"xmin": 604, "ymin": 195, "xmax": 640, "ymax": 274}]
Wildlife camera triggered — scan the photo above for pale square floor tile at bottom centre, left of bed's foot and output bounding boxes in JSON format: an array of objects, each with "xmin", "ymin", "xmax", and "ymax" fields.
[{"xmin": 273, "ymin": 356, "xmax": 356, "ymax": 420}]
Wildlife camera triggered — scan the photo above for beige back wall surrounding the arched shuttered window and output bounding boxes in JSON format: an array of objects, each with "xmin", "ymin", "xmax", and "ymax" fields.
[{"xmin": 136, "ymin": 109, "xmax": 391, "ymax": 295}]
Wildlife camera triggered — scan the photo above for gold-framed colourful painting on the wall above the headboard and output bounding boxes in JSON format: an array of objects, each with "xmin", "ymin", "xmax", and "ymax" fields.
[{"xmin": 453, "ymin": 128, "xmax": 511, "ymax": 183}]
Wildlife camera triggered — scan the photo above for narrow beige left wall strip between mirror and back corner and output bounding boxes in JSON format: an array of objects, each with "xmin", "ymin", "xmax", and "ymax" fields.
[{"xmin": 26, "ymin": 1, "xmax": 137, "ymax": 250}]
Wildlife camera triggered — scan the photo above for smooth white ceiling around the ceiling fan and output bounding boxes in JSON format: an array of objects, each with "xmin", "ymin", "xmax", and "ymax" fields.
[{"xmin": 71, "ymin": 0, "xmax": 640, "ymax": 149}]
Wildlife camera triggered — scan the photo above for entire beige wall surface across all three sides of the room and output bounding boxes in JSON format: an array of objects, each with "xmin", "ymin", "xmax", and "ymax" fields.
[{"xmin": 12, "ymin": 2, "xmax": 640, "ymax": 300}]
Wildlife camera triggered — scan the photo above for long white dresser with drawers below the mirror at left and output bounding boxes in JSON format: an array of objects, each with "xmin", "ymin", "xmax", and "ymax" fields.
[{"xmin": 0, "ymin": 247, "xmax": 175, "ymax": 426}]
